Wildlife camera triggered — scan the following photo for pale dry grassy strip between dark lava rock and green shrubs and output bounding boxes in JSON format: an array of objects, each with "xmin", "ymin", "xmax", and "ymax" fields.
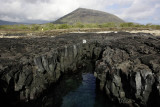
[{"xmin": 0, "ymin": 28, "xmax": 160, "ymax": 38}]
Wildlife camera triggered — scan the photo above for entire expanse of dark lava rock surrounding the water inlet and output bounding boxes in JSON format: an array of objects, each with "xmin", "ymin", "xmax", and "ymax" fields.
[{"xmin": 0, "ymin": 32, "xmax": 160, "ymax": 106}]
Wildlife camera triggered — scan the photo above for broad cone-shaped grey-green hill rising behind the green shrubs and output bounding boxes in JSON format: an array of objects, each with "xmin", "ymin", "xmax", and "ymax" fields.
[{"xmin": 53, "ymin": 8, "xmax": 124, "ymax": 24}]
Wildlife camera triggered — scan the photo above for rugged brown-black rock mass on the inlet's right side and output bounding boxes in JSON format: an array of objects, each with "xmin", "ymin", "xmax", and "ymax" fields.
[{"xmin": 94, "ymin": 33, "xmax": 160, "ymax": 106}]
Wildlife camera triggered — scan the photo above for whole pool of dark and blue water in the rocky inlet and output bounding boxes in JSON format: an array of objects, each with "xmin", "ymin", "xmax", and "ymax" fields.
[{"xmin": 42, "ymin": 73, "xmax": 115, "ymax": 107}]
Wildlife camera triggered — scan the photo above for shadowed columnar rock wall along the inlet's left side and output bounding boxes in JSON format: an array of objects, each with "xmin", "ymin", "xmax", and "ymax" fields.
[{"xmin": 2, "ymin": 39, "xmax": 102, "ymax": 101}]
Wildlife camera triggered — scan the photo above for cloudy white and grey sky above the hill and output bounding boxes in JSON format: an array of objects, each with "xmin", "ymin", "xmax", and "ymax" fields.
[{"xmin": 0, "ymin": 0, "xmax": 160, "ymax": 24}]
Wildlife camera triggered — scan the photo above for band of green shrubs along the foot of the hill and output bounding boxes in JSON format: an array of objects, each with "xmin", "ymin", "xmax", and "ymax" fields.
[{"xmin": 0, "ymin": 22, "xmax": 160, "ymax": 31}]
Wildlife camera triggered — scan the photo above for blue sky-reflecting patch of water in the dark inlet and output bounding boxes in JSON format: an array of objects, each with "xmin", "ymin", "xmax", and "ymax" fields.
[{"xmin": 62, "ymin": 73, "xmax": 96, "ymax": 107}]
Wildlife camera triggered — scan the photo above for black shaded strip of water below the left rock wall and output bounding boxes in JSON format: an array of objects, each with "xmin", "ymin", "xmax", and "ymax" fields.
[{"xmin": 43, "ymin": 74, "xmax": 82, "ymax": 107}]
